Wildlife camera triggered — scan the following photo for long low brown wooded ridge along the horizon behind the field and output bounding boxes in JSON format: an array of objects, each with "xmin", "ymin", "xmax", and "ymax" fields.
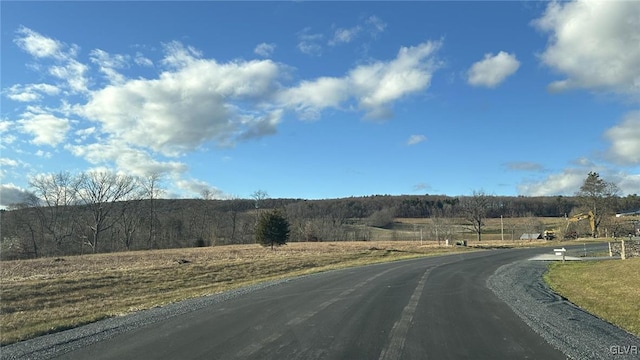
[{"xmin": 0, "ymin": 194, "xmax": 640, "ymax": 259}]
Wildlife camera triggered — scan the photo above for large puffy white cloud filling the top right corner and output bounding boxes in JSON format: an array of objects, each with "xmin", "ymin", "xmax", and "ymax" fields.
[{"xmin": 533, "ymin": 0, "xmax": 640, "ymax": 100}]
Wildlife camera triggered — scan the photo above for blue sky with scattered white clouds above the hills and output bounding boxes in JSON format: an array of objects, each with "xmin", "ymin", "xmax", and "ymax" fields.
[{"xmin": 0, "ymin": 1, "xmax": 640, "ymax": 206}]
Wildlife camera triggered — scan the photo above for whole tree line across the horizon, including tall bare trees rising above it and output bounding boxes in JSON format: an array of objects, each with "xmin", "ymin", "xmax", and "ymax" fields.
[{"xmin": 0, "ymin": 172, "xmax": 640, "ymax": 259}]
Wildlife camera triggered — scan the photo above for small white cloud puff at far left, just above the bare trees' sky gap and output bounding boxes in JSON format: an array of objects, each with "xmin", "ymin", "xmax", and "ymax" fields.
[{"xmin": 18, "ymin": 111, "xmax": 71, "ymax": 146}]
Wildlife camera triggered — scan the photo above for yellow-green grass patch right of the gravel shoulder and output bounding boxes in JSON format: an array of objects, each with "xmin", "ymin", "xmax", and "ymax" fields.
[{"xmin": 544, "ymin": 258, "xmax": 640, "ymax": 336}]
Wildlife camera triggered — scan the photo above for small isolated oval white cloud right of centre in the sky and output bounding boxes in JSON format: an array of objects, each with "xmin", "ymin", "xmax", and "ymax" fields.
[{"xmin": 467, "ymin": 51, "xmax": 520, "ymax": 88}]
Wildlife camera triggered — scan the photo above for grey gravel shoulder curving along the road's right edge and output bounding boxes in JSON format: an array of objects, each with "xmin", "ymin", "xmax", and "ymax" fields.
[{"xmin": 487, "ymin": 260, "xmax": 640, "ymax": 359}]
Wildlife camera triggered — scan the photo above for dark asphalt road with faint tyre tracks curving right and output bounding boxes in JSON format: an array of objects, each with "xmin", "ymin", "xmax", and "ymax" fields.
[{"xmin": 48, "ymin": 249, "xmax": 566, "ymax": 360}]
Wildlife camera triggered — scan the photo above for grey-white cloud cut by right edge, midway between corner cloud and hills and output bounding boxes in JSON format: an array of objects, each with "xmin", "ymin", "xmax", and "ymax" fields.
[{"xmin": 604, "ymin": 111, "xmax": 640, "ymax": 165}]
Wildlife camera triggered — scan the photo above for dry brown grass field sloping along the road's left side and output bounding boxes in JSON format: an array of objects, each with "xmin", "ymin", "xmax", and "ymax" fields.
[{"xmin": 0, "ymin": 241, "xmax": 470, "ymax": 345}]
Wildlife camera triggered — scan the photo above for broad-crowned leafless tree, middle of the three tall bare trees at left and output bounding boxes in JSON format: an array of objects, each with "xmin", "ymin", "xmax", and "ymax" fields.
[{"xmin": 78, "ymin": 172, "xmax": 136, "ymax": 253}]
